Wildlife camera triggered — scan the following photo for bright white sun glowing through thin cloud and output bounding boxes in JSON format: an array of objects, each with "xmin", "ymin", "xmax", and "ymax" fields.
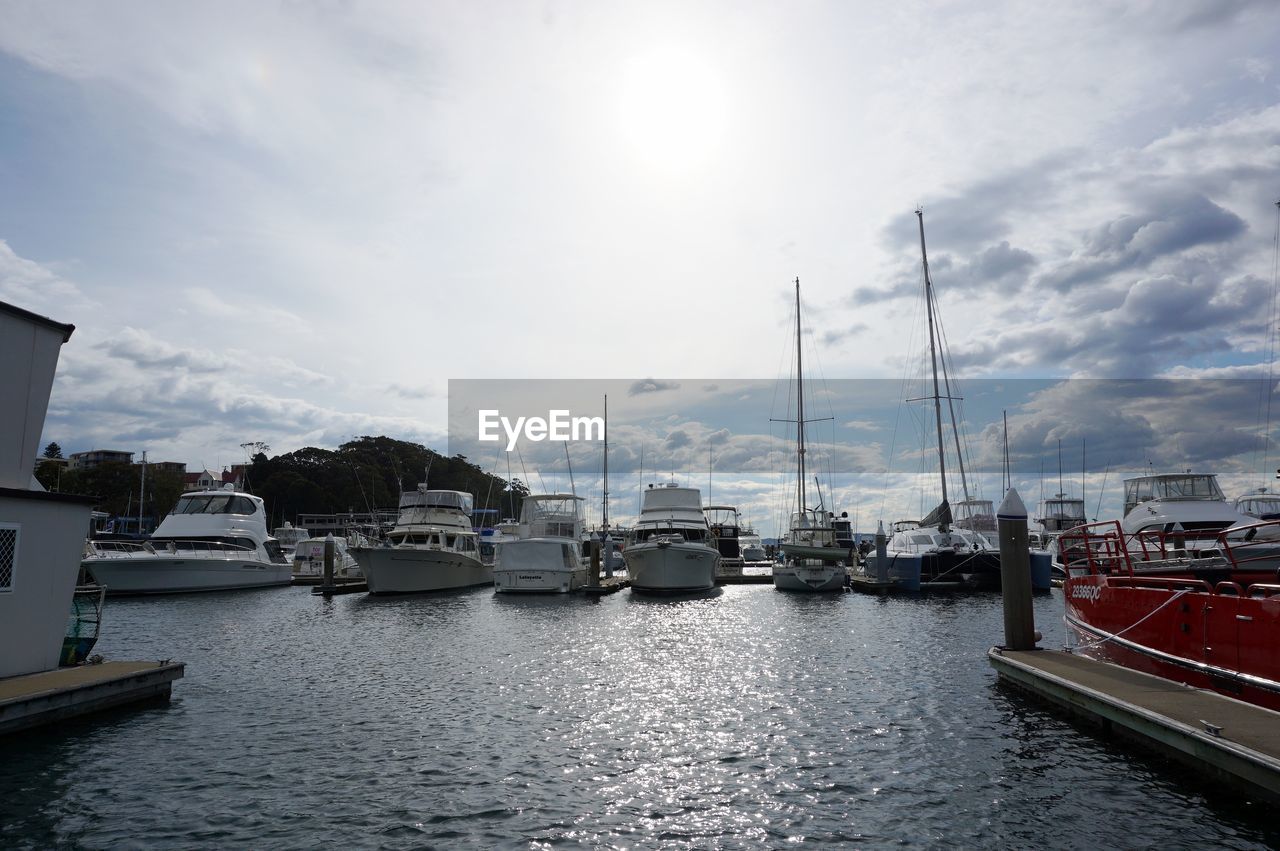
[{"xmin": 618, "ymin": 46, "xmax": 726, "ymax": 173}]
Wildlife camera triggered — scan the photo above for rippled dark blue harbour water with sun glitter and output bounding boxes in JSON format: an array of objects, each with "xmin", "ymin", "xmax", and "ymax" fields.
[{"xmin": 0, "ymin": 586, "xmax": 1280, "ymax": 848}]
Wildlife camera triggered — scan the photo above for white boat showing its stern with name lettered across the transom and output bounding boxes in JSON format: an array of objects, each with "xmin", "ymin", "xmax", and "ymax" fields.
[{"xmin": 493, "ymin": 494, "xmax": 590, "ymax": 594}]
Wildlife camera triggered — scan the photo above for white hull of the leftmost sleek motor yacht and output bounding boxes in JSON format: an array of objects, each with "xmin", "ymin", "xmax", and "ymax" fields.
[{"xmin": 81, "ymin": 554, "xmax": 292, "ymax": 596}]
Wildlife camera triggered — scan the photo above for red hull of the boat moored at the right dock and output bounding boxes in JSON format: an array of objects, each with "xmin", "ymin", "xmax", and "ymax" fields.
[{"xmin": 1064, "ymin": 575, "xmax": 1280, "ymax": 712}]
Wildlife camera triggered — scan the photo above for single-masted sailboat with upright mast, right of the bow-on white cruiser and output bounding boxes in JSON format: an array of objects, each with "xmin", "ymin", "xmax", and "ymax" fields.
[{"xmin": 773, "ymin": 278, "xmax": 852, "ymax": 591}]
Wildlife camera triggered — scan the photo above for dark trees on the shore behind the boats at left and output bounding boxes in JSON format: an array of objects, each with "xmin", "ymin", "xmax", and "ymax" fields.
[{"xmin": 36, "ymin": 436, "xmax": 529, "ymax": 527}]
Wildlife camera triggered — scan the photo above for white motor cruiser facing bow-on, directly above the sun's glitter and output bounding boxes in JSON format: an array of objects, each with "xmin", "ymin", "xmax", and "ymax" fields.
[{"xmin": 622, "ymin": 482, "xmax": 721, "ymax": 594}]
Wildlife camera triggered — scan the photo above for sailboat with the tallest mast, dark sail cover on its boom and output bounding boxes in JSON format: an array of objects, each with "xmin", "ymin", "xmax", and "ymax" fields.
[{"xmin": 887, "ymin": 210, "xmax": 1000, "ymax": 589}]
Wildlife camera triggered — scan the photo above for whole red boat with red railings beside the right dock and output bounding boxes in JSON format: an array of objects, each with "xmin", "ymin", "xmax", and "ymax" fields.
[{"xmin": 1060, "ymin": 521, "xmax": 1280, "ymax": 712}]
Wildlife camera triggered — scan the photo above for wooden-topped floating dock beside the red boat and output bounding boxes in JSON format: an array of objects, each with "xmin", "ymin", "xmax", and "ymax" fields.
[{"xmin": 987, "ymin": 648, "xmax": 1280, "ymax": 801}]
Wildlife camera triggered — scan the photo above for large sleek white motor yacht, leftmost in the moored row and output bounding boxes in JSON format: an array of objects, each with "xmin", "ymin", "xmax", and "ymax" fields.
[{"xmin": 81, "ymin": 485, "xmax": 291, "ymax": 596}]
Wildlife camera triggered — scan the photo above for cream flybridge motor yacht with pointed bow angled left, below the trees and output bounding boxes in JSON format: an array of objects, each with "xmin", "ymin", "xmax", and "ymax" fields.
[{"xmin": 351, "ymin": 482, "xmax": 493, "ymax": 594}]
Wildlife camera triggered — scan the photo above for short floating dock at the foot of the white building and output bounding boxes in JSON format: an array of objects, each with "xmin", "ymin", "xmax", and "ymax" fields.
[{"xmin": 0, "ymin": 660, "xmax": 186, "ymax": 736}]
